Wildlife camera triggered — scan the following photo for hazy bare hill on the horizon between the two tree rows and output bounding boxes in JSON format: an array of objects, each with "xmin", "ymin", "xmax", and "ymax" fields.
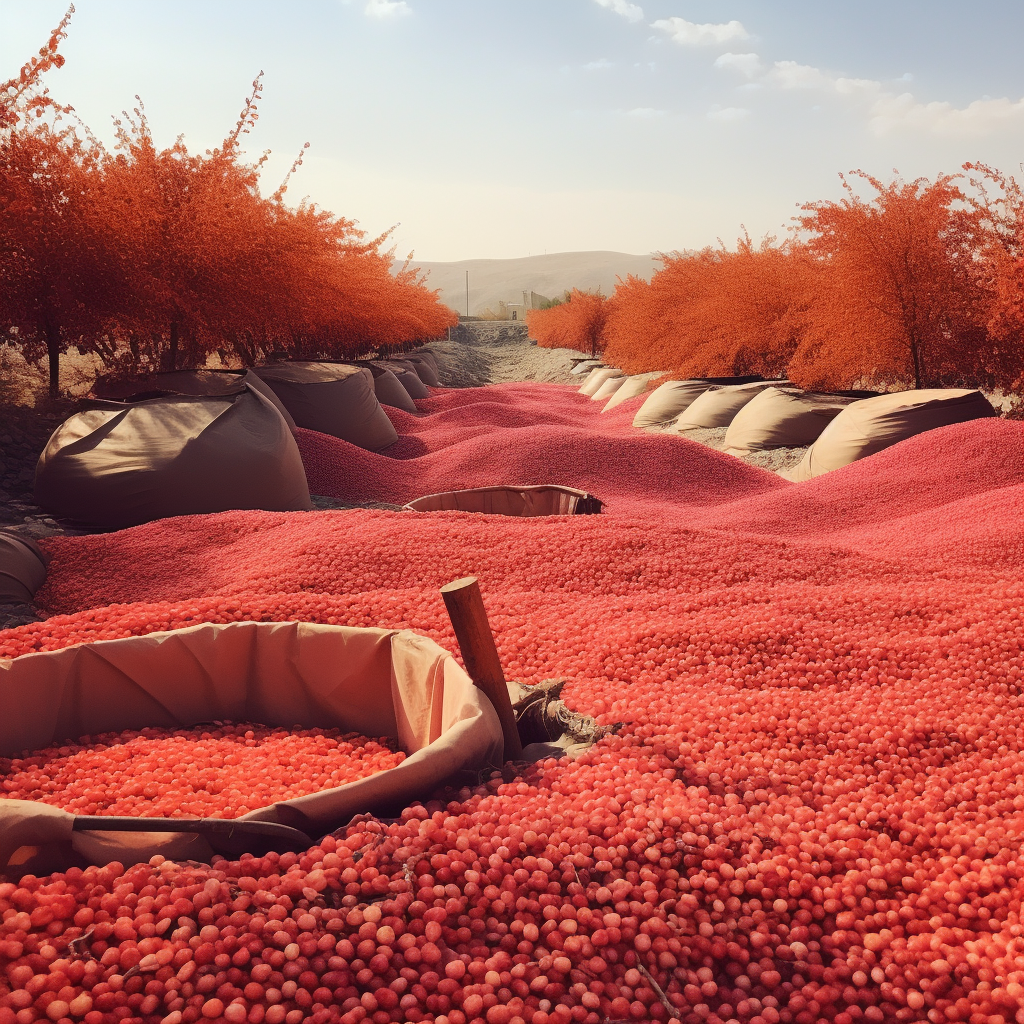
[{"xmin": 396, "ymin": 252, "xmax": 659, "ymax": 316}]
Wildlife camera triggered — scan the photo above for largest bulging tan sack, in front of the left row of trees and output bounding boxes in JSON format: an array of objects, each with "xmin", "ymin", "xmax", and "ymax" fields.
[{"xmin": 36, "ymin": 386, "xmax": 311, "ymax": 529}]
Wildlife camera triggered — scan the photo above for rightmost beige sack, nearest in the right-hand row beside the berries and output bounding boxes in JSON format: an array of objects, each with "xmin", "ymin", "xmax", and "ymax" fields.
[{"xmin": 781, "ymin": 388, "xmax": 996, "ymax": 482}]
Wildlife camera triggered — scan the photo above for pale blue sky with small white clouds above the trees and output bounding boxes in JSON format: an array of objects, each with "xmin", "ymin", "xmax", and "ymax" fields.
[{"xmin": 0, "ymin": 0, "xmax": 1024, "ymax": 261}]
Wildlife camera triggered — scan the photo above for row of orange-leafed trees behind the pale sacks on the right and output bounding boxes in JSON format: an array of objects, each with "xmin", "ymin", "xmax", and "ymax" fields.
[{"xmin": 527, "ymin": 165, "xmax": 1024, "ymax": 391}]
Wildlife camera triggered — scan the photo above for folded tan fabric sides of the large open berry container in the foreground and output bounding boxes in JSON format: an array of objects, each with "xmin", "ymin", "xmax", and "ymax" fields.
[{"xmin": 0, "ymin": 623, "xmax": 503, "ymax": 870}]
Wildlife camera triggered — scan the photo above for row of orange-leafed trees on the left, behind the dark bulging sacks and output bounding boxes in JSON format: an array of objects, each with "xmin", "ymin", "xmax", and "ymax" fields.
[{"xmin": 0, "ymin": 7, "xmax": 457, "ymax": 393}]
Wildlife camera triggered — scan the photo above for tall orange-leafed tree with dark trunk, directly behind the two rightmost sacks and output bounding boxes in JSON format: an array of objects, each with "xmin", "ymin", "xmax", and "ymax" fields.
[{"xmin": 790, "ymin": 171, "xmax": 986, "ymax": 388}]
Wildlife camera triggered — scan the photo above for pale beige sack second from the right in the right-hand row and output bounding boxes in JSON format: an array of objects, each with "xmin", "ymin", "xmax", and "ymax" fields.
[{"xmin": 723, "ymin": 387, "xmax": 857, "ymax": 457}]
